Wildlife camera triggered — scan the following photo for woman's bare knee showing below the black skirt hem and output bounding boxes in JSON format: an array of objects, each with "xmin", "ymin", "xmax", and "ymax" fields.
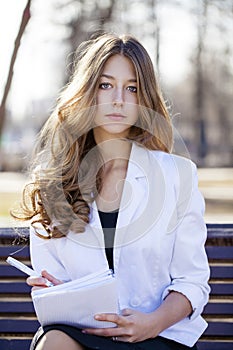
[{"xmin": 36, "ymin": 330, "xmax": 85, "ymax": 350}]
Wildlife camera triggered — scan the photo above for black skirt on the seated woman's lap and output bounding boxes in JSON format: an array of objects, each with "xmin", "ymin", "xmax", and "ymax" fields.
[{"xmin": 30, "ymin": 324, "xmax": 197, "ymax": 350}]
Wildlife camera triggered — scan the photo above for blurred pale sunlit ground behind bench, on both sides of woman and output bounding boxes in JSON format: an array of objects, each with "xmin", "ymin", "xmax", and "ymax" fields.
[{"xmin": 0, "ymin": 168, "xmax": 233, "ymax": 227}]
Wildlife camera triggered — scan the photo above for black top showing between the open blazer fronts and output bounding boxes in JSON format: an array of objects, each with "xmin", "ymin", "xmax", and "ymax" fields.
[{"xmin": 99, "ymin": 210, "xmax": 118, "ymax": 270}]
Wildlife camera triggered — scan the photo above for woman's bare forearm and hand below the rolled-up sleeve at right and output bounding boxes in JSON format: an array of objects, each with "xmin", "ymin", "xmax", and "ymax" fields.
[{"xmin": 83, "ymin": 291, "xmax": 192, "ymax": 343}]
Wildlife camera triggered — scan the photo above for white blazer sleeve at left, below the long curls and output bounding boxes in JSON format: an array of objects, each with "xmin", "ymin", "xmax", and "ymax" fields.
[{"xmin": 30, "ymin": 226, "xmax": 70, "ymax": 282}]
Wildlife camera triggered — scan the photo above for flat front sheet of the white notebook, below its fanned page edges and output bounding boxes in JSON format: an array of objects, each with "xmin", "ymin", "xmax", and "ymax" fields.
[{"xmin": 33, "ymin": 277, "xmax": 119, "ymax": 328}]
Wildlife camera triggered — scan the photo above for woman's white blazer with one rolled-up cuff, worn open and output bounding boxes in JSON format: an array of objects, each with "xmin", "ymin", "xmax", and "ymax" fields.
[{"xmin": 30, "ymin": 143, "xmax": 210, "ymax": 346}]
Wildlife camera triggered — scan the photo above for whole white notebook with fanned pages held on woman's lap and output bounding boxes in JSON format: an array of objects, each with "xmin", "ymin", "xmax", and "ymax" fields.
[{"xmin": 32, "ymin": 270, "xmax": 119, "ymax": 328}]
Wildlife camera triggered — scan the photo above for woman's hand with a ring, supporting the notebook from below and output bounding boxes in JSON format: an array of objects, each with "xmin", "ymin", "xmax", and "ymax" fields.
[{"xmin": 83, "ymin": 309, "xmax": 159, "ymax": 343}]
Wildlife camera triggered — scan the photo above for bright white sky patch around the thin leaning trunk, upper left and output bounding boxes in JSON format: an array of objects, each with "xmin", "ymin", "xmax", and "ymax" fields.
[{"xmin": 0, "ymin": 0, "xmax": 67, "ymax": 118}]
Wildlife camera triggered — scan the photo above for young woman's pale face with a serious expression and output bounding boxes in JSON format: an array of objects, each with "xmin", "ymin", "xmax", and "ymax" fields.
[{"xmin": 94, "ymin": 54, "xmax": 138, "ymax": 141}]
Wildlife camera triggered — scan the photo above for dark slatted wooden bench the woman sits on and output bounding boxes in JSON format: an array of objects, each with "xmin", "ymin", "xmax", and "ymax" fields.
[{"xmin": 0, "ymin": 224, "xmax": 233, "ymax": 350}]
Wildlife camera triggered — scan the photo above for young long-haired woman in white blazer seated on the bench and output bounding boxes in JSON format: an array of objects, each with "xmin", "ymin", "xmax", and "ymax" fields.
[{"xmin": 15, "ymin": 34, "xmax": 209, "ymax": 350}]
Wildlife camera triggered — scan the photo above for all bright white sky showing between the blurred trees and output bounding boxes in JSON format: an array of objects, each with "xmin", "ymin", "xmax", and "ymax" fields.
[{"xmin": 0, "ymin": 0, "xmax": 195, "ymax": 119}]
